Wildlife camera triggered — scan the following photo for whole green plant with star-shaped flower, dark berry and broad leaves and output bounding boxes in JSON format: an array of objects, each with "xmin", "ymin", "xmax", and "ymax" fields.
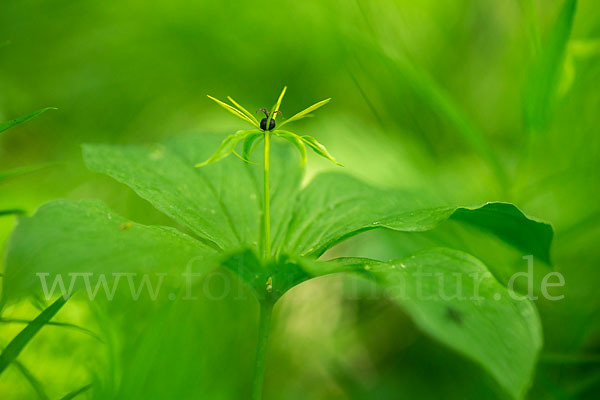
[{"xmin": 3, "ymin": 89, "xmax": 552, "ymax": 399}]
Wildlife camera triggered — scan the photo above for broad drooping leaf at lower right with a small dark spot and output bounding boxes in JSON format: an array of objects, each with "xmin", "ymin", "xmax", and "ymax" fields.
[{"xmin": 324, "ymin": 248, "xmax": 543, "ymax": 399}]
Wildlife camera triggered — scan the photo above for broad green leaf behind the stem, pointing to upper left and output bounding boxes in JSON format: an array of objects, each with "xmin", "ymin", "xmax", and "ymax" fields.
[{"xmin": 83, "ymin": 135, "xmax": 303, "ymax": 253}]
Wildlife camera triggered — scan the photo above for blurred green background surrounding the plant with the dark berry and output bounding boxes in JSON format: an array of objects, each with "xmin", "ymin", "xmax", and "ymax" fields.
[{"xmin": 0, "ymin": 0, "xmax": 600, "ymax": 399}]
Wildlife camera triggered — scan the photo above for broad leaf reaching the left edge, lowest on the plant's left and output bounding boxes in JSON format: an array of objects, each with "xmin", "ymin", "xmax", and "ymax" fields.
[{"xmin": 3, "ymin": 200, "xmax": 214, "ymax": 299}]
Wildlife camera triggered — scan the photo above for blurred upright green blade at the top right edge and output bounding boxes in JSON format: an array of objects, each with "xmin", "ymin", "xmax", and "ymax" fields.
[{"xmin": 523, "ymin": 0, "xmax": 577, "ymax": 131}]
